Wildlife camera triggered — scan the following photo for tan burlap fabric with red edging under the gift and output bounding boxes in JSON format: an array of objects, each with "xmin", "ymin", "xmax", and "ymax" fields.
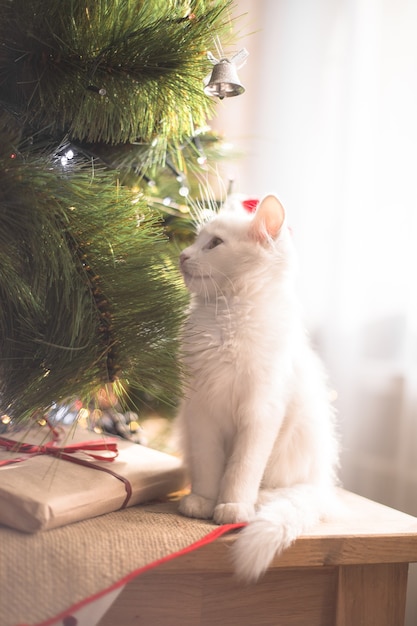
[{"xmin": 0, "ymin": 501, "xmax": 237, "ymax": 626}]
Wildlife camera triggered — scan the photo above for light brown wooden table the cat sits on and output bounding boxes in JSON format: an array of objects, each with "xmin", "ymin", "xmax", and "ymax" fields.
[{"xmin": 100, "ymin": 492, "xmax": 417, "ymax": 626}]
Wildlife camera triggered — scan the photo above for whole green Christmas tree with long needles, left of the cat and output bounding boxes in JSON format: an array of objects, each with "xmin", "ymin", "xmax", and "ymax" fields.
[{"xmin": 0, "ymin": 0, "xmax": 237, "ymax": 422}]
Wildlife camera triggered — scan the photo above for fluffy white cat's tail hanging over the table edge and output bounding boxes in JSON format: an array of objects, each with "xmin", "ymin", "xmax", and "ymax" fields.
[{"xmin": 232, "ymin": 484, "xmax": 335, "ymax": 582}]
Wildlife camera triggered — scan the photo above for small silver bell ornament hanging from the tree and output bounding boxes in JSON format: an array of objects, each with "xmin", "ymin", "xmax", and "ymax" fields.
[{"xmin": 204, "ymin": 48, "xmax": 249, "ymax": 100}]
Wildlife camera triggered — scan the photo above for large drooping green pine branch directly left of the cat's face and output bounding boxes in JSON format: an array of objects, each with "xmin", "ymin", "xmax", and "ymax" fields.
[{"xmin": 0, "ymin": 133, "xmax": 185, "ymax": 418}]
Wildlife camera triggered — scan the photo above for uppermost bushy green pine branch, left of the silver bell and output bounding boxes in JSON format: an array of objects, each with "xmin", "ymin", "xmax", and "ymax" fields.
[{"xmin": 0, "ymin": 0, "xmax": 234, "ymax": 145}]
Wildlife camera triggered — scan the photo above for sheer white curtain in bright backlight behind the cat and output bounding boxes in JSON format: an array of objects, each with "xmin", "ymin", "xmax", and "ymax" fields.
[{"xmin": 214, "ymin": 0, "xmax": 417, "ymax": 626}]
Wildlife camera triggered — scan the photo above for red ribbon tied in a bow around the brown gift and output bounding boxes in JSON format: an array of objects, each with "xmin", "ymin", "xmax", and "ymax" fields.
[{"xmin": 0, "ymin": 424, "xmax": 132, "ymax": 509}]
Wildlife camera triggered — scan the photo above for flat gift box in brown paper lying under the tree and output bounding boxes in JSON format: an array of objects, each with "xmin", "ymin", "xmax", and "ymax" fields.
[{"xmin": 0, "ymin": 425, "xmax": 187, "ymax": 533}]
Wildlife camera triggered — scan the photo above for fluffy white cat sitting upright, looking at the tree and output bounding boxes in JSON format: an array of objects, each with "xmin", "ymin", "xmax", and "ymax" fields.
[{"xmin": 179, "ymin": 195, "xmax": 338, "ymax": 581}]
